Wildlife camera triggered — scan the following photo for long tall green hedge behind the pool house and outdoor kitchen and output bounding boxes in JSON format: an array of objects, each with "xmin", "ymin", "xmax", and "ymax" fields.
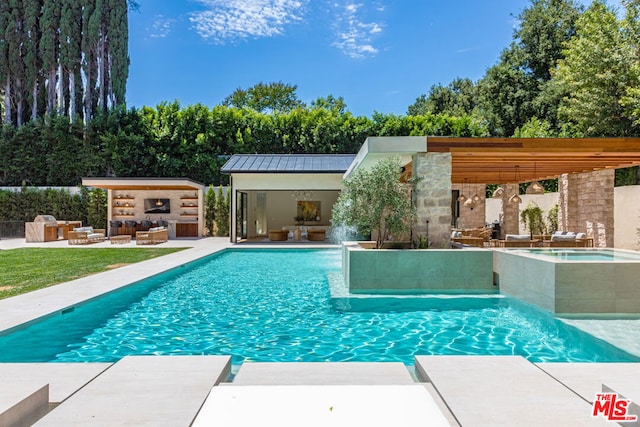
[{"xmin": 0, "ymin": 102, "xmax": 486, "ymax": 186}]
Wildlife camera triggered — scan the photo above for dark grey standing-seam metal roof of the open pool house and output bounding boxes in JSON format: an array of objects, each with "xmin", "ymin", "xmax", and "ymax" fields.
[{"xmin": 220, "ymin": 154, "xmax": 356, "ymax": 174}]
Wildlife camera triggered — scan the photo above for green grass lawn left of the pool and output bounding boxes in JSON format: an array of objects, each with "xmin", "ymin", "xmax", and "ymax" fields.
[{"xmin": 0, "ymin": 248, "xmax": 184, "ymax": 299}]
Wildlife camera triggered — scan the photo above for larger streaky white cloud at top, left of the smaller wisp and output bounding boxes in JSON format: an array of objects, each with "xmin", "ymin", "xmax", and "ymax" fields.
[{"xmin": 189, "ymin": 0, "xmax": 307, "ymax": 44}]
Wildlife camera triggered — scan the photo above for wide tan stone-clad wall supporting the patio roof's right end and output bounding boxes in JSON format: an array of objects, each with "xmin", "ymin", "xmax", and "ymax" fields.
[{"xmin": 558, "ymin": 169, "xmax": 615, "ymax": 247}]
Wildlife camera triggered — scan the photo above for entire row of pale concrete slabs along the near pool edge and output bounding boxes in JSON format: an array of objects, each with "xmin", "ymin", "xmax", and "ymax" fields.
[{"xmin": 0, "ymin": 356, "xmax": 640, "ymax": 427}]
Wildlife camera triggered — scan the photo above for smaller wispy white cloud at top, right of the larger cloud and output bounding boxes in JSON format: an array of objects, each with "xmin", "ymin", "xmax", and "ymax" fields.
[{"xmin": 333, "ymin": 1, "xmax": 384, "ymax": 59}]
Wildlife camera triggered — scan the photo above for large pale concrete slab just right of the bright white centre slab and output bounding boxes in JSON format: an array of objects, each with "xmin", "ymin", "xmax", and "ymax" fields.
[{"xmin": 415, "ymin": 356, "xmax": 610, "ymax": 427}]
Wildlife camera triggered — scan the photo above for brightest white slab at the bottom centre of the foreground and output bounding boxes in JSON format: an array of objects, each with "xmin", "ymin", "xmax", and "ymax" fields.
[{"xmin": 193, "ymin": 384, "xmax": 450, "ymax": 427}]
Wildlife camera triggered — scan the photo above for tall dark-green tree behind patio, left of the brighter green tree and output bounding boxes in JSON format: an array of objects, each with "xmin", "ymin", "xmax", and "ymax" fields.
[{"xmin": 478, "ymin": 0, "xmax": 582, "ymax": 136}]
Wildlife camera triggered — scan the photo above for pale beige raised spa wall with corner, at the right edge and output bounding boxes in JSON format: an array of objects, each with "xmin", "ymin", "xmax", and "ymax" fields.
[{"xmin": 494, "ymin": 251, "xmax": 640, "ymax": 315}]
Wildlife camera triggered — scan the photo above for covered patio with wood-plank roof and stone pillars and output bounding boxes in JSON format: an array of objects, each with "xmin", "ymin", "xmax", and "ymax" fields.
[{"xmin": 345, "ymin": 136, "xmax": 640, "ymax": 248}]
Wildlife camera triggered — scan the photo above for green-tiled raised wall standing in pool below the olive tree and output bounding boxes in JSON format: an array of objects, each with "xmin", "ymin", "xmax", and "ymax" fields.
[{"xmin": 342, "ymin": 242, "xmax": 497, "ymax": 294}]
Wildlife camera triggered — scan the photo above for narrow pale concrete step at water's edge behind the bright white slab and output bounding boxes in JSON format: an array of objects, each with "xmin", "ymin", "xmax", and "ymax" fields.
[{"xmin": 229, "ymin": 362, "xmax": 415, "ymax": 386}]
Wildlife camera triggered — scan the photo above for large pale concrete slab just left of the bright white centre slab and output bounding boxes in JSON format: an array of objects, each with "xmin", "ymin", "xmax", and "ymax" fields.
[{"xmin": 37, "ymin": 356, "xmax": 231, "ymax": 427}]
